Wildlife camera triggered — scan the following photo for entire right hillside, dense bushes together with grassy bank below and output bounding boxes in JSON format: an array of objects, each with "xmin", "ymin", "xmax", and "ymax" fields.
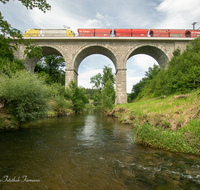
[{"xmin": 115, "ymin": 38, "xmax": 200, "ymax": 154}]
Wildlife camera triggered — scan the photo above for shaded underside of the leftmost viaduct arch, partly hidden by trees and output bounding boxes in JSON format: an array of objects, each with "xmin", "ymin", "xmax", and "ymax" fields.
[{"xmin": 25, "ymin": 45, "xmax": 66, "ymax": 73}]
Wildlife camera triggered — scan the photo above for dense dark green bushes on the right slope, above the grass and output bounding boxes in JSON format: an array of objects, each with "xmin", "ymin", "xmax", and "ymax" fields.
[{"xmin": 133, "ymin": 38, "xmax": 200, "ymax": 99}]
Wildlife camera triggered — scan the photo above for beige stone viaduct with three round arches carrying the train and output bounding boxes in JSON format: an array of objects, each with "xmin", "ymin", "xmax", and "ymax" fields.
[{"xmin": 14, "ymin": 37, "xmax": 193, "ymax": 104}]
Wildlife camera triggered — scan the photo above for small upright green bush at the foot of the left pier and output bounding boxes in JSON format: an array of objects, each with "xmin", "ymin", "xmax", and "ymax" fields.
[{"xmin": 65, "ymin": 81, "xmax": 88, "ymax": 113}]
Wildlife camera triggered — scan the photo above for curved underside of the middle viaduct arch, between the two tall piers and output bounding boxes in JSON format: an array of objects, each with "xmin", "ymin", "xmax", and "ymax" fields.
[{"xmin": 73, "ymin": 44, "xmax": 117, "ymax": 73}]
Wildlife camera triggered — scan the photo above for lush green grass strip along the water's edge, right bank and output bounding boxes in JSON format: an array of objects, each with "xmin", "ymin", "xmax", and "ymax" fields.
[{"xmin": 134, "ymin": 120, "xmax": 200, "ymax": 154}]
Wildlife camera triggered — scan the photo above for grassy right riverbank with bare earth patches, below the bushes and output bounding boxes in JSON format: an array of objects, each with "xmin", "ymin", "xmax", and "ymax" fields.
[{"xmin": 108, "ymin": 90, "xmax": 200, "ymax": 154}]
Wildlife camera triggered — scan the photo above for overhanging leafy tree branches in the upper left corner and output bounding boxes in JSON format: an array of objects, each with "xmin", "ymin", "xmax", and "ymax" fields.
[{"xmin": 0, "ymin": 0, "xmax": 51, "ymax": 61}]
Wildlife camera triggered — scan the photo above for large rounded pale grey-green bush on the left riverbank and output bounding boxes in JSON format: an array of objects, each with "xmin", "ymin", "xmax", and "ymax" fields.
[{"xmin": 0, "ymin": 71, "xmax": 51, "ymax": 122}]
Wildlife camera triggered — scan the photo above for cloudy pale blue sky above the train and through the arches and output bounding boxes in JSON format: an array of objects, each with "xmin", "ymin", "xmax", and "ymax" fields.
[{"xmin": 0, "ymin": 0, "xmax": 200, "ymax": 93}]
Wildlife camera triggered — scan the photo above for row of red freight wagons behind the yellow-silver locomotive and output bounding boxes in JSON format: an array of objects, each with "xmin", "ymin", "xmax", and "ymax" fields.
[{"xmin": 78, "ymin": 29, "xmax": 200, "ymax": 38}]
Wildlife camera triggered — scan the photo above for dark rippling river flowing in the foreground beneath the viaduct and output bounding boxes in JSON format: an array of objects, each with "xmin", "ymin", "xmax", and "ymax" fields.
[{"xmin": 0, "ymin": 110, "xmax": 200, "ymax": 190}]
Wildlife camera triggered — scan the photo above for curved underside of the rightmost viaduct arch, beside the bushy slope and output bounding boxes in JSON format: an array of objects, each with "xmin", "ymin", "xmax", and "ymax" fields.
[{"xmin": 126, "ymin": 45, "xmax": 170, "ymax": 68}]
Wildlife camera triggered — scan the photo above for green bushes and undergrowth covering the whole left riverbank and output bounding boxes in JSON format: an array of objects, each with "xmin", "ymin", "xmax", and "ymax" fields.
[{"xmin": 0, "ymin": 58, "xmax": 88, "ymax": 131}]
